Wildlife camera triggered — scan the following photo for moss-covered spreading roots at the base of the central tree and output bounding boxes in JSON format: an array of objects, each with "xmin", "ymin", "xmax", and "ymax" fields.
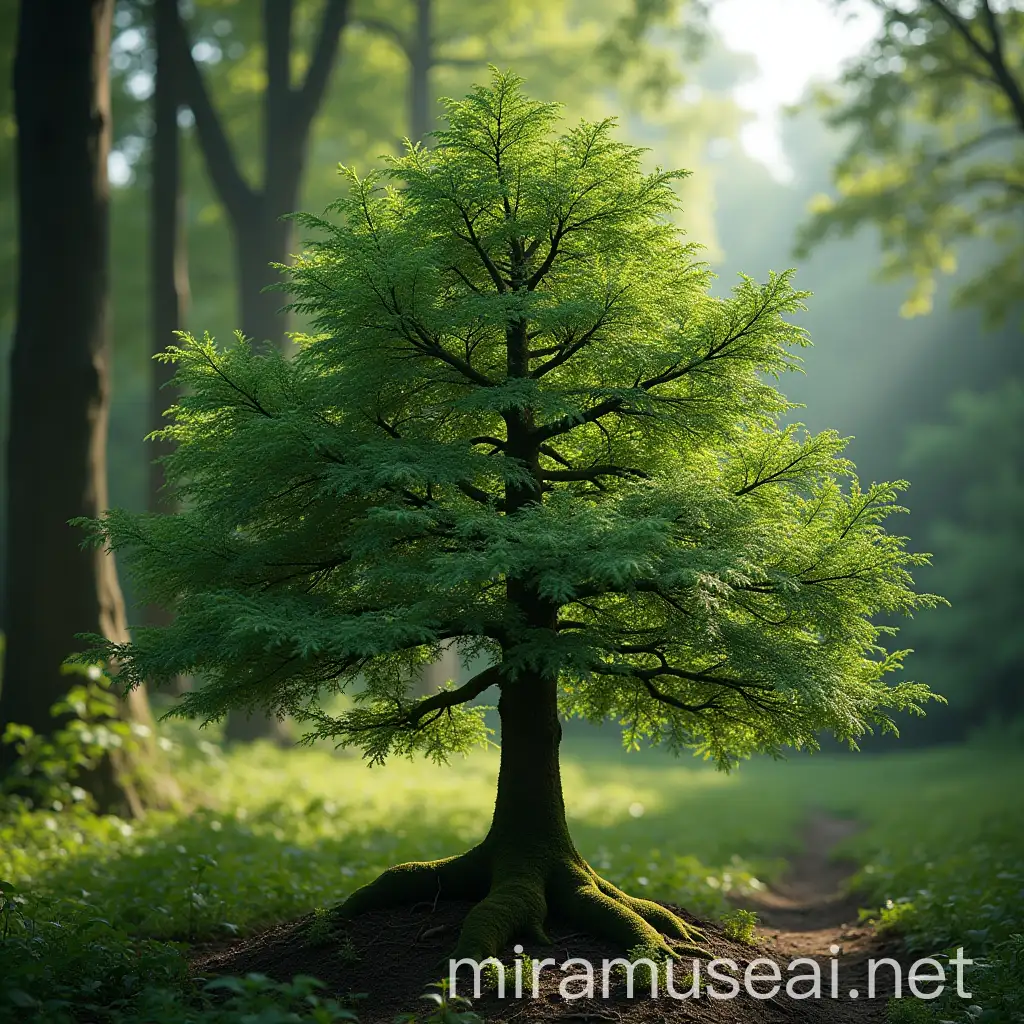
[{"xmin": 338, "ymin": 841, "xmax": 710, "ymax": 961}]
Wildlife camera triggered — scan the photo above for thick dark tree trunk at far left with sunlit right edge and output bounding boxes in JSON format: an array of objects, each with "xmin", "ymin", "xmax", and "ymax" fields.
[{"xmin": 0, "ymin": 0, "xmax": 159, "ymax": 813}]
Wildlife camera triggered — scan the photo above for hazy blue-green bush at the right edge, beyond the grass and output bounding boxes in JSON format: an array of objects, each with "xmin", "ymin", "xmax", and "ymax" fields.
[{"xmin": 906, "ymin": 380, "xmax": 1024, "ymax": 724}]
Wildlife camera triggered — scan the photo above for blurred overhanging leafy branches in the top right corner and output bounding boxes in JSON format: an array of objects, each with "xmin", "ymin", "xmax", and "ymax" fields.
[{"xmin": 799, "ymin": 0, "xmax": 1024, "ymax": 323}]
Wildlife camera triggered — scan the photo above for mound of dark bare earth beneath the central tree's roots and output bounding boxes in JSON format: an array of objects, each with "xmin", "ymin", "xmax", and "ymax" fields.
[{"xmin": 193, "ymin": 902, "xmax": 901, "ymax": 1024}]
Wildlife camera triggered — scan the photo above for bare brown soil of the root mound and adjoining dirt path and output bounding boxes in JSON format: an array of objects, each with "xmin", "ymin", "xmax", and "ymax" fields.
[{"xmin": 193, "ymin": 813, "xmax": 903, "ymax": 1024}]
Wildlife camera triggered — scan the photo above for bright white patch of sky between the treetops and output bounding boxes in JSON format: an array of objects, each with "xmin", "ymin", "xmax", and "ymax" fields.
[{"xmin": 712, "ymin": 0, "xmax": 882, "ymax": 181}]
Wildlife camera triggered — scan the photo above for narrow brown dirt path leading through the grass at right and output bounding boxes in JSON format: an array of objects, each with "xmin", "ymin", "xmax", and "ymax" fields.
[{"xmin": 739, "ymin": 814, "xmax": 901, "ymax": 1021}]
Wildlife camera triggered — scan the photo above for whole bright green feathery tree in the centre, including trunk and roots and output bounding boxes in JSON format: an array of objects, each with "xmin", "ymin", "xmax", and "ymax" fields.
[{"xmin": 81, "ymin": 74, "xmax": 936, "ymax": 955}]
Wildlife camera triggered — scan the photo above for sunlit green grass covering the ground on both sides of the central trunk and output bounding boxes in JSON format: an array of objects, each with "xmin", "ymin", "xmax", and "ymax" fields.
[{"xmin": 0, "ymin": 708, "xmax": 1024, "ymax": 1022}]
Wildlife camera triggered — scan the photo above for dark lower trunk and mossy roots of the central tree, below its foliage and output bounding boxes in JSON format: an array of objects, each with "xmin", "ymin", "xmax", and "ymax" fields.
[{"xmin": 339, "ymin": 651, "xmax": 703, "ymax": 959}]
